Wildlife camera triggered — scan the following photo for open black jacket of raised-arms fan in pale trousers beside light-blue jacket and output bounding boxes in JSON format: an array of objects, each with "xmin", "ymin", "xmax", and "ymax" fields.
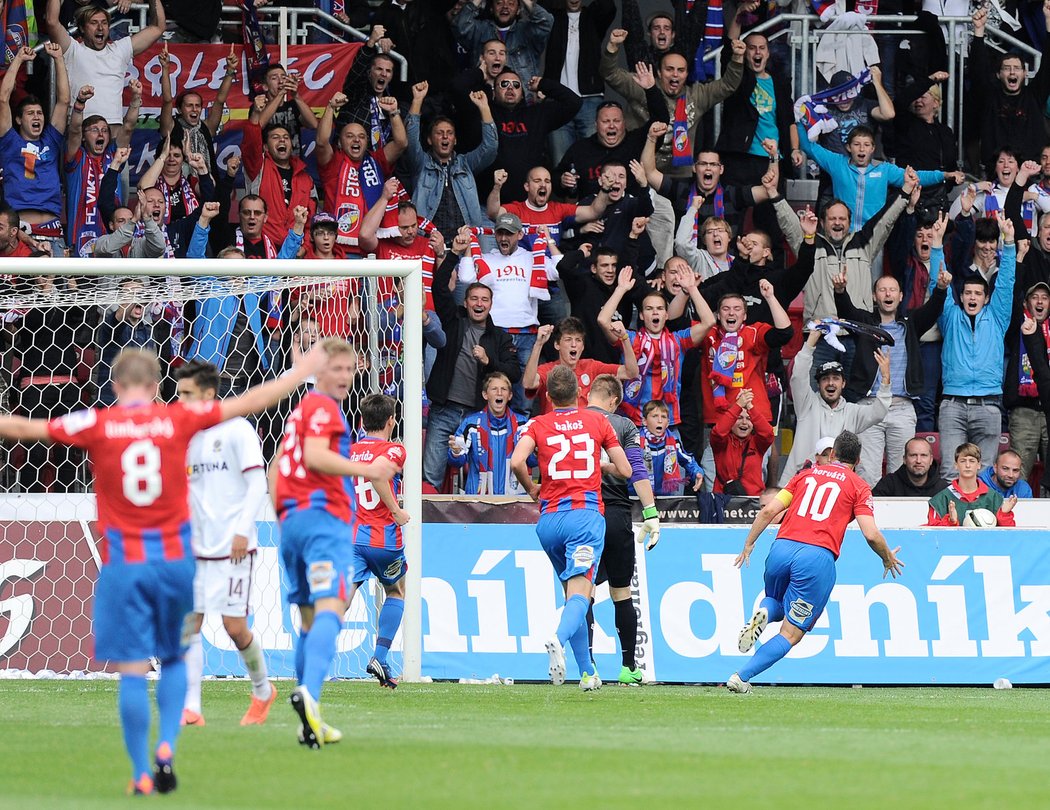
[{"xmin": 835, "ymin": 289, "xmax": 947, "ymax": 402}]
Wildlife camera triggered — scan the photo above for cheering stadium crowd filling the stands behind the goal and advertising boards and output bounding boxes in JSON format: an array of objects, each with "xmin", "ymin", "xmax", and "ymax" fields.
[{"xmin": 6, "ymin": 0, "xmax": 1050, "ymax": 523}]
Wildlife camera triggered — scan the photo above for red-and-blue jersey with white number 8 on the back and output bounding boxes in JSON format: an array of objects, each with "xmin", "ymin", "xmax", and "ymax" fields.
[{"xmin": 47, "ymin": 402, "xmax": 222, "ymax": 565}]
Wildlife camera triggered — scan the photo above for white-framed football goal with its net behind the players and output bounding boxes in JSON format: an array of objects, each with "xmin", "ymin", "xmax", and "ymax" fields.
[{"xmin": 0, "ymin": 258, "xmax": 423, "ymax": 680}]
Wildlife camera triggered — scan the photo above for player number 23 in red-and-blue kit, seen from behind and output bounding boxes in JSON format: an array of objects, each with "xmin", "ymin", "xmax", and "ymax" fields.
[{"xmin": 510, "ymin": 366, "xmax": 631, "ymax": 691}]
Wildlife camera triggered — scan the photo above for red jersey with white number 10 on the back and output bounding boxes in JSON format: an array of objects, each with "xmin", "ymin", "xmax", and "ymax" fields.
[{"xmin": 777, "ymin": 463, "xmax": 875, "ymax": 559}]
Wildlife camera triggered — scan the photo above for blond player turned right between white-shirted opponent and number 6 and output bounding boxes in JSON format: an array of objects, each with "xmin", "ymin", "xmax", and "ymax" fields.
[{"xmin": 270, "ymin": 337, "xmax": 408, "ymax": 748}]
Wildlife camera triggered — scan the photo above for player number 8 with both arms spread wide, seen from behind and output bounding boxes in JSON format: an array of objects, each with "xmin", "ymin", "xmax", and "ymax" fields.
[{"xmin": 0, "ymin": 349, "xmax": 326, "ymax": 793}]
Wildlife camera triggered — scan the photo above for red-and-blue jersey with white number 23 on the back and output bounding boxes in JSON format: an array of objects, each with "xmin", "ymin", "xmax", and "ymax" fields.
[{"xmin": 522, "ymin": 408, "xmax": 620, "ymax": 515}]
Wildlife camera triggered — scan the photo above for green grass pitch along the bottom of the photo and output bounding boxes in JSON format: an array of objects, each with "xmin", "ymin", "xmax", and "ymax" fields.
[{"xmin": 0, "ymin": 681, "xmax": 1050, "ymax": 810}]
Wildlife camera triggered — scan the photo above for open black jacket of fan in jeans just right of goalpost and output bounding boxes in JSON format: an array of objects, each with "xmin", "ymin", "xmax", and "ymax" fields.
[{"xmin": 426, "ymin": 250, "xmax": 522, "ymax": 410}]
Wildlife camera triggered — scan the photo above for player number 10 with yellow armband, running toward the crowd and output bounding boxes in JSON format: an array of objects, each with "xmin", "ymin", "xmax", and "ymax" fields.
[{"xmin": 726, "ymin": 431, "xmax": 904, "ymax": 694}]
